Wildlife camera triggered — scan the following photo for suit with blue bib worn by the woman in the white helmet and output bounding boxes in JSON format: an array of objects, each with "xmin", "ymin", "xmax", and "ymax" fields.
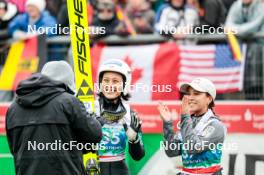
[{"xmin": 95, "ymin": 96, "xmax": 145, "ymax": 175}]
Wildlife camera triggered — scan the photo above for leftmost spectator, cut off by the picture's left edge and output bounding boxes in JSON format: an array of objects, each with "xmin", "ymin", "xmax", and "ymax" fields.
[{"xmin": 0, "ymin": 0, "xmax": 17, "ymax": 39}]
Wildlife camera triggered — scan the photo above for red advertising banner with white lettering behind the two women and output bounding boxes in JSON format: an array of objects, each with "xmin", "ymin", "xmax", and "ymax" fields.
[{"xmin": 0, "ymin": 101, "xmax": 264, "ymax": 134}]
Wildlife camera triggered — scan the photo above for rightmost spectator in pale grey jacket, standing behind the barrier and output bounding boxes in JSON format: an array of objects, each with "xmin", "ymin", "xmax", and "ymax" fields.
[{"xmin": 226, "ymin": 0, "xmax": 264, "ymax": 100}]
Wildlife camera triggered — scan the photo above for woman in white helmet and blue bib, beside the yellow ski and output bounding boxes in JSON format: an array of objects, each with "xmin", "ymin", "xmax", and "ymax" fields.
[{"xmin": 95, "ymin": 59, "xmax": 145, "ymax": 175}]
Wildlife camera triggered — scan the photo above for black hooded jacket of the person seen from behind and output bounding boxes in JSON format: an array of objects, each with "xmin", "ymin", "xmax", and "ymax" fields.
[{"xmin": 6, "ymin": 74, "xmax": 102, "ymax": 175}]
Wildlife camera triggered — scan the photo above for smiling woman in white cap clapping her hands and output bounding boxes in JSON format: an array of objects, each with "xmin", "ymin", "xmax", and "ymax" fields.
[{"xmin": 158, "ymin": 78, "xmax": 226, "ymax": 175}]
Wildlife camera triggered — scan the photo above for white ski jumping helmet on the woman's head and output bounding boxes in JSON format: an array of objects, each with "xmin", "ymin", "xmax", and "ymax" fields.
[{"xmin": 98, "ymin": 59, "xmax": 132, "ymax": 95}]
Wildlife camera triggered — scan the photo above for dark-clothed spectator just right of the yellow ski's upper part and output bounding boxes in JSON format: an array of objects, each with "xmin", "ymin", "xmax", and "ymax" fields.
[{"xmin": 91, "ymin": 0, "xmax": 119, "ymax": 38}]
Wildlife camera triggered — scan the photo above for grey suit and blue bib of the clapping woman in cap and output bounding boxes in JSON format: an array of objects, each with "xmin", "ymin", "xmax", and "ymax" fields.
[{"xmin": 163, "ymin": 109, "xmax": 226, "ymax": 175}]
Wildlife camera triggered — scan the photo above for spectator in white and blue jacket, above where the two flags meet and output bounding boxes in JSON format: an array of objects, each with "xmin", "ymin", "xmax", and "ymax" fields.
[{"xmin": 155, "ymin": 0, "xmax": 199, "ymax": 39}]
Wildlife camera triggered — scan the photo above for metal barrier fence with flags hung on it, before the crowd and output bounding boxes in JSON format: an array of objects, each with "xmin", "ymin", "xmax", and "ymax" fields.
[{"xmin": 0, "ymin": 33, "xmax": 264, "ymax": 100}]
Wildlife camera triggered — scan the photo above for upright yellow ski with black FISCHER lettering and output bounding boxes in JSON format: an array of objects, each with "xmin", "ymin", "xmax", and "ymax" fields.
[{"xmin": 67, "ymin": 0, "xmax": 97, "ymax": 170}]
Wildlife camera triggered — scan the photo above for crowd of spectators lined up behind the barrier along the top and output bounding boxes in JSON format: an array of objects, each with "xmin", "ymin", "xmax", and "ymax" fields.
[{"xmin": 0, "ymin": 0, "xmax": 264, "ymax": 42}]
